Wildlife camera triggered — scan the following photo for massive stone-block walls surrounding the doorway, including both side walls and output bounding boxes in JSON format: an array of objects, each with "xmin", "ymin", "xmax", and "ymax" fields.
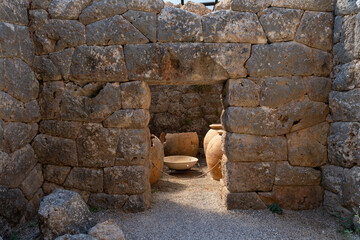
[{"xmin": 0, "ymin": 0, "xmax": 360, "ymax": 235}]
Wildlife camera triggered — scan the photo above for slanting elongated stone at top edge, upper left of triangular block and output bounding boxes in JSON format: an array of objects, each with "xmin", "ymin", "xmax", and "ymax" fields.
[{"xmin": 79, "ymin": 0, "xmax": 127, "ymax": 24}]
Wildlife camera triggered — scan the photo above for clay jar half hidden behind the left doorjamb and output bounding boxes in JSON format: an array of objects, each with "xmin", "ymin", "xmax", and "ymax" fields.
[{"xmin": 150, "ymin": 135, "xmax": 164, "ymax": 184}]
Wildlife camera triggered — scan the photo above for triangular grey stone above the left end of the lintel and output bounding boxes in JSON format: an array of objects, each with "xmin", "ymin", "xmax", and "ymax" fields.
[{"xmin": 123, "ymin": 10, "xmax": 157, "ymax": 42}]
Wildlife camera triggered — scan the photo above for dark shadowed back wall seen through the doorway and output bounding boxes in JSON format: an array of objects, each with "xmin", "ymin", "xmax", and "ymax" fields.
[{"xmin": 149, "ymin": 83, "xmax": 223, "ymax": 150}]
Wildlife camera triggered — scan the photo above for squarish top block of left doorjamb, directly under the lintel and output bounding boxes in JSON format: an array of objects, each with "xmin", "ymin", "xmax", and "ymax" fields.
[{"xmin": 120, "ymin": 81, "xmax": 151, "ymax": 109}]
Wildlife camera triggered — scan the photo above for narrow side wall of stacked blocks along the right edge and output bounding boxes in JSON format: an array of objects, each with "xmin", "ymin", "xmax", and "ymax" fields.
[{"xmin": 322, "ymin": 0, "xmax": 360, "ymax": 215}]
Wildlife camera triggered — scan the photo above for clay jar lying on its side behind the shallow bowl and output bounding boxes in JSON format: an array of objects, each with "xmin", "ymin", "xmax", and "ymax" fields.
[{"xmin": 164, "ymin": 132, "xmax": 199, "ymax": 157}]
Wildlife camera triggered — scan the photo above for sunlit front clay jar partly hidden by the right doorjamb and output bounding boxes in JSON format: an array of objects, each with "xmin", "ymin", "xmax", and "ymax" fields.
[{"xmin": 206, "ymin": 132, "xmax": 223, "ymax": 180}]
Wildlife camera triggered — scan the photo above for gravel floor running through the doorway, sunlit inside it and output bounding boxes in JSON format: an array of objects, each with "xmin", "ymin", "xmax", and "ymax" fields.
[{"xmin": 12, "ymin": 159, "xmax": 352, "ymax": 240}]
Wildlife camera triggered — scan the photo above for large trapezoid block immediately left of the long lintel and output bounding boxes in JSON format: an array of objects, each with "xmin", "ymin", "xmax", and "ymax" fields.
[{"xmin": 70, "ymin": 46, "xmax": 127, "ymax": 82}]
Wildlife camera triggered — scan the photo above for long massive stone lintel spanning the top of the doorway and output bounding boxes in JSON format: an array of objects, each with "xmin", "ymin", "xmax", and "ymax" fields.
[{"xmin": 125, "ymin": 43, "xmax": 250, "ymax": 84}]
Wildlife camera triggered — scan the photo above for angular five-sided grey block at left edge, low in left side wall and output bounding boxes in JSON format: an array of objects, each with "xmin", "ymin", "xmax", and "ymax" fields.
[{"xmin": 0, "ymin": 145, "xmax": 37, "ymax": 188}]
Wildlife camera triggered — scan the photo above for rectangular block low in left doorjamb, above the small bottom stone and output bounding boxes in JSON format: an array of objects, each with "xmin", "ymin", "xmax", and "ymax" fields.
[{"xmin": 104, "ymin": 166, "xmax": 149, "ymax": 195}]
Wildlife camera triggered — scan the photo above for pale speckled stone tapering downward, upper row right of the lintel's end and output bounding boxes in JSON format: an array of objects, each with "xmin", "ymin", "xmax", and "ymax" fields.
[{"xmin": 259, "ymin": 8, "xmax": 303, "ymax": 42}]
